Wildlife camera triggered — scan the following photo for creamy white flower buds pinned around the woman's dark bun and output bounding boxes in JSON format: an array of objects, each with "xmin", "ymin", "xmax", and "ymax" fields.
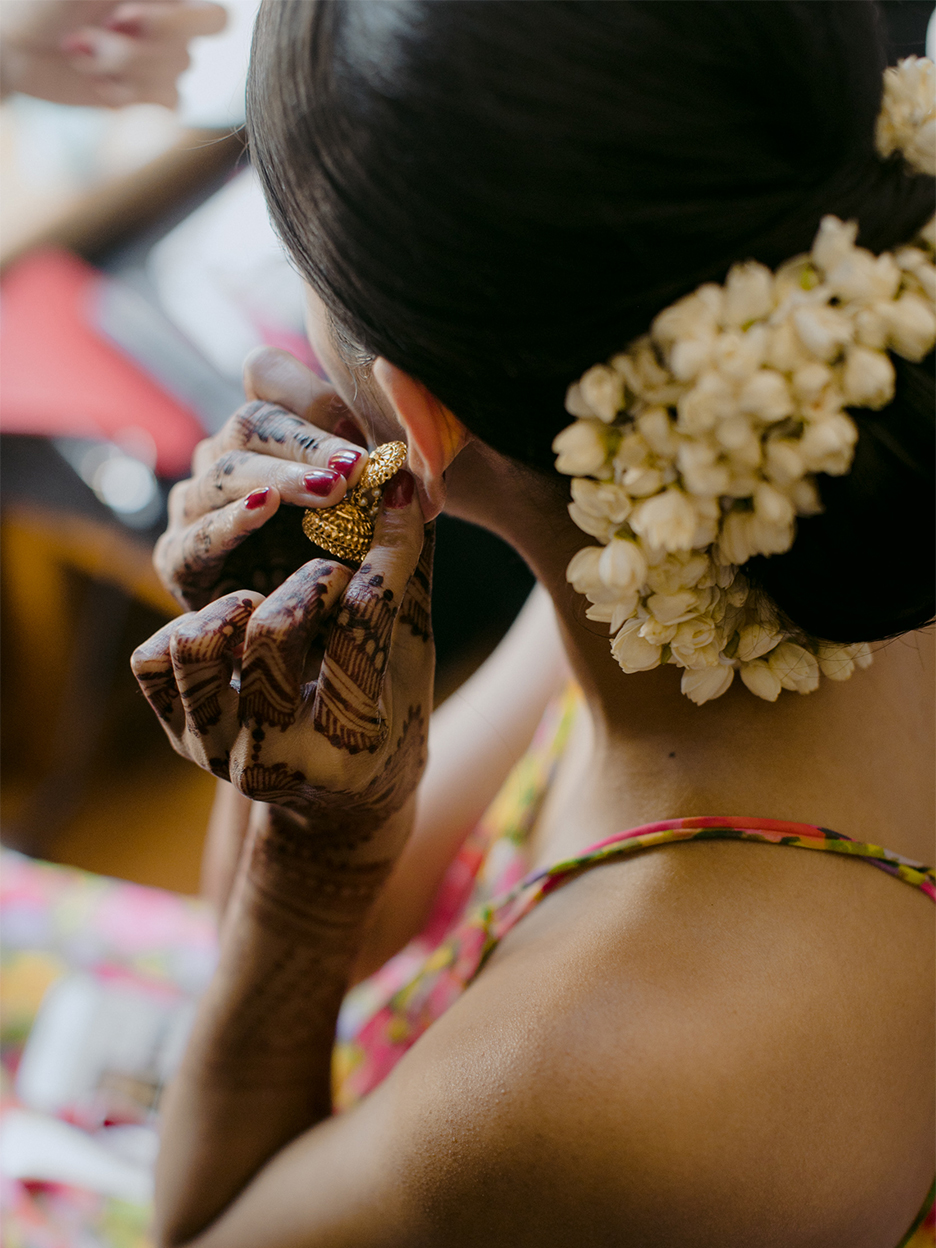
[{"xmin": 553, "ymin": 57, "xmax": 936, "ymax": 704}]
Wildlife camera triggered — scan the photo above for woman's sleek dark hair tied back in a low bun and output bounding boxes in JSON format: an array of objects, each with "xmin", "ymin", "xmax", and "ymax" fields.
[{"xmin": 248, "ymin": 0, "xmax": 936, "ymax": 641}]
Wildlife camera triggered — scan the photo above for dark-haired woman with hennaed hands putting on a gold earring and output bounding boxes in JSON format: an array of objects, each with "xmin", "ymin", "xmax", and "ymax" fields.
[{"xmin": 135, "ymin": 0, "xmax": 936, "ymax": 1248}]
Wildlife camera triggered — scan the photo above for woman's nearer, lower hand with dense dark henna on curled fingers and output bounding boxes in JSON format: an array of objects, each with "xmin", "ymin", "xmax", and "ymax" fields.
[{"xmin": 131, "ymin": 476, "xmax": 434, "ymax": 841}]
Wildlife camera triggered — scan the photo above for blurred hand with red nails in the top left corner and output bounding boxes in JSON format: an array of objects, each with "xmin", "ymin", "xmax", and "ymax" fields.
[{"xmin": 0, "ymin": 0, "xmax": 227, "ymax": 109}]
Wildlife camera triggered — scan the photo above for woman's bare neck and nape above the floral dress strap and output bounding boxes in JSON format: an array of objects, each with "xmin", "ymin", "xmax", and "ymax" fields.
[{"xmin": 448, "ymin": 444, "xmax": 936, "ymax": 861}]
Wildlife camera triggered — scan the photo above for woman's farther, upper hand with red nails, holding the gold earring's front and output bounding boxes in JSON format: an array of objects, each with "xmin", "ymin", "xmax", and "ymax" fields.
[{"xmin": 154, "ymin": 348, "xmax": 367, "ymax": 610}]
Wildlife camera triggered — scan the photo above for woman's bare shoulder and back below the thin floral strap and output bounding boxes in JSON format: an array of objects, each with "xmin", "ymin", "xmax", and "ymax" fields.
[{"xmin": 382, "ymin": 845, "xmax": 934, "ymax": 1248}]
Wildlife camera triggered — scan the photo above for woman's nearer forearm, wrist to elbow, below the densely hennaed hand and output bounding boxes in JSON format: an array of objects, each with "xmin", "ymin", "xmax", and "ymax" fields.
[{"xmin": 157, "ymin": 807, "xmax": 409, "ymax": 1246}]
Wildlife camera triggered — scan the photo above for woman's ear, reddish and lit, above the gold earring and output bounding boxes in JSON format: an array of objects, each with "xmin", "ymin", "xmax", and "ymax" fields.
[{"xmin": 372, "ymin": 358, "xmax": 470, "ymax": 520}]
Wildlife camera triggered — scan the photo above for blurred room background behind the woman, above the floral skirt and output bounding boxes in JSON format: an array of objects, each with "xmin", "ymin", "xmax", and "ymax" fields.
[{"xmin": 0, "ymin": 0, "xmax": 532, "ymax": 892}]
